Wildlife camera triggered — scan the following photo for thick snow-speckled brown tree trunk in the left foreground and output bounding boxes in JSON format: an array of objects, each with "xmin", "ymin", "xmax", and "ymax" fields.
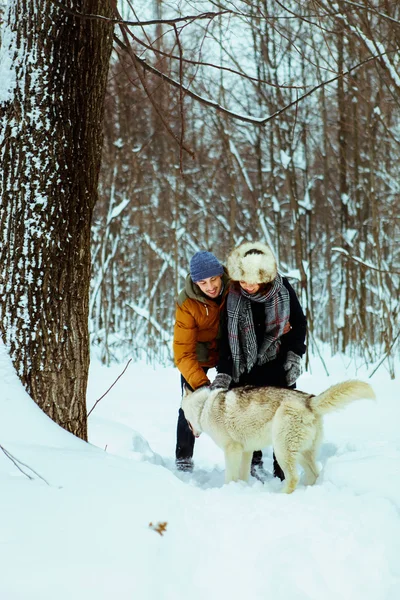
[{"xmin": 0, "ymin": 0, "xmax": 113, "ymax": 439}]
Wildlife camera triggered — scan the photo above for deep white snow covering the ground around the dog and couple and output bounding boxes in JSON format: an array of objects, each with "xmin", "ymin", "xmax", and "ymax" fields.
[{"xmin": 0, "ymin": 346, "xmax": 400, "ymax": 600}]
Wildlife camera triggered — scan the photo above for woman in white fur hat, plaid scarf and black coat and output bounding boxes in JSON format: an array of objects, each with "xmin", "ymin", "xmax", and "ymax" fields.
[{"xmin": 211, "ymin": 242, "xmax": 307, "ymax": 480}]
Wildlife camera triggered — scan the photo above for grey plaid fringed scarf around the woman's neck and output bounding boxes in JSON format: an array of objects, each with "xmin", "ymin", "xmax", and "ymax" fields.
[{"xmin": 226, "ymin": 274, "xmax": 290, "ymax": 381}]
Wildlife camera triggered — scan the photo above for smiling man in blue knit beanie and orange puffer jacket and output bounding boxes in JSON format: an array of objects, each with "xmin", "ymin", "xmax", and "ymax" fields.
[{"xmin": 173, "ymin": 251, "xmax": 229, "ymax": 471}]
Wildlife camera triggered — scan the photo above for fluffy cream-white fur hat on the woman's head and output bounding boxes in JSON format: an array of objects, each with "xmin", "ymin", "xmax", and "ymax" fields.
[{"xmin": 227, "ymin": 242, "xmax": 277, "ymax": 283}]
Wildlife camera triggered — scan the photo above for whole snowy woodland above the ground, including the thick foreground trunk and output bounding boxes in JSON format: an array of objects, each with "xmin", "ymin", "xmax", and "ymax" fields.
[{"xmin": 0, "ymin": 0, "xmax": 400, "ymax": 439}]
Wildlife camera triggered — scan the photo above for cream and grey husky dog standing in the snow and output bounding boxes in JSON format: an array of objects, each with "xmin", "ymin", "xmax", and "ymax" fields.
[{"xmin": 182, "ymin": 380, "xmax": 375, "ymax": 494}]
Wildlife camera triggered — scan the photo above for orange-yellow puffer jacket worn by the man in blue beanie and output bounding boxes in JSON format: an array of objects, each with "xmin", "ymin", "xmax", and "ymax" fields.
[{"xmin": 173, "ymin": 272, "xmax": 229, "ymax": 390}]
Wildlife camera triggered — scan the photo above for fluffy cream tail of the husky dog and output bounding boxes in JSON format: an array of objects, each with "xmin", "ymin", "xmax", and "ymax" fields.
[{"xmin": 309, "ymin": 379, "xmax": 376, "ymax": 415}]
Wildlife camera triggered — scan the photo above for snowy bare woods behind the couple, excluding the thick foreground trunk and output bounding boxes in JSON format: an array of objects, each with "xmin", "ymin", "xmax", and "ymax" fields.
[{"xmin": 90, "ymin": 0, "xmax": 400, "ymax": 370}]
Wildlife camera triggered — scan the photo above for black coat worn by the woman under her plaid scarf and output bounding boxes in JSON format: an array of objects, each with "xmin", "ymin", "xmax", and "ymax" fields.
[{"xmin": 217, "ymin": 277, "xmax": 307, "ymax": 387}]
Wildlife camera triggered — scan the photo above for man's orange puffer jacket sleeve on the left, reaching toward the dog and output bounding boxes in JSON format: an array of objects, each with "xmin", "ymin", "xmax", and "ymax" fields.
[{"xmin": 173, "ymin": 303, "xmax": 210, "ymax": 390}]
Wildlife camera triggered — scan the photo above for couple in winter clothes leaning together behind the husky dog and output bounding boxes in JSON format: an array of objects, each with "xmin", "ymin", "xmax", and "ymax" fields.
[{"xmin": 174, "ymin": 242, "xmax": 307, "ymax": 480}]
